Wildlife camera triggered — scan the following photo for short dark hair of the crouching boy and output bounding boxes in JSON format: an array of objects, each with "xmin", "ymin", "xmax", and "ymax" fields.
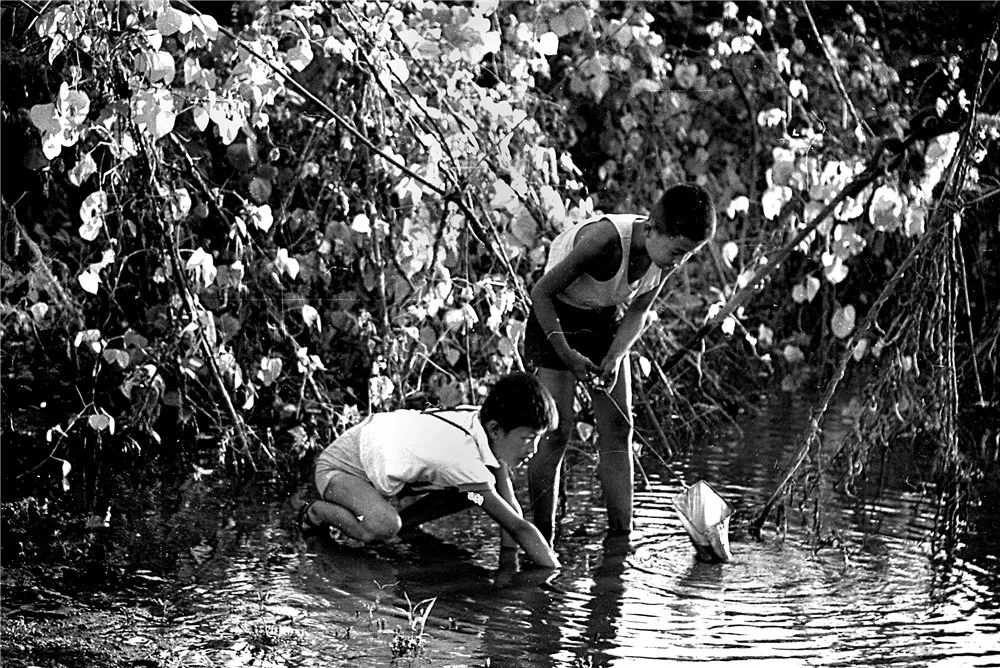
[{"xmin": 479, "ymin": 372, "xmax": 559, "ymax": 431}]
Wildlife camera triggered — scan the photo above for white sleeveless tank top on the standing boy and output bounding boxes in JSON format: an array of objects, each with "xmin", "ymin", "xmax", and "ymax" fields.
[{"xmin": 545, "ymin": 213, "xmax": 660, "ymax": 310}]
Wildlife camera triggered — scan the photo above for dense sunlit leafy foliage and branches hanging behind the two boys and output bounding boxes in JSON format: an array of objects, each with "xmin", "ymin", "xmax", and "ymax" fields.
[{"xmin": 2, "ymin": 0, "xmax": 1000, "ymax": 516}]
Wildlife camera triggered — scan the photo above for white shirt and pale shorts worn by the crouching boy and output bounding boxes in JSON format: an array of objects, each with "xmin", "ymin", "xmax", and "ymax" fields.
[{"xmin": 316, "ymin": 410, "xmax": 500, "ymax": 496}]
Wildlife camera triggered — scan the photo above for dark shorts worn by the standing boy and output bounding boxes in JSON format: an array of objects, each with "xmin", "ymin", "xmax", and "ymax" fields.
[{"xmin": 524, "ymin": 299, "xmax": 618, "ymax": 371}]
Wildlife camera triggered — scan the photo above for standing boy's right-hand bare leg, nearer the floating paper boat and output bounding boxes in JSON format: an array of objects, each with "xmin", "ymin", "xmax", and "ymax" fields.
[{"xmin": 591, "ymin": 357, "xmax": 635, "ymax": 533}]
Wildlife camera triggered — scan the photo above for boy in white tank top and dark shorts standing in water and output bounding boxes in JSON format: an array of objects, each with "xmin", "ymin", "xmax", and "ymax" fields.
[{"xmin": 525, "ymin": 184, "xmax": 715, "ymax": 543}]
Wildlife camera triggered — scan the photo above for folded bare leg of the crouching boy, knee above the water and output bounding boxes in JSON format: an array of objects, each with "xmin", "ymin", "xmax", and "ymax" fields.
[{"xmin": 310, "ymin": 471, "xmax": 402, "ymax": 543}]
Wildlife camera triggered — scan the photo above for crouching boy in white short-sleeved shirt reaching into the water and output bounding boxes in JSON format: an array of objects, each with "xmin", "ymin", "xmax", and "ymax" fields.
[{"xmin": 302, "ymin": 373, "xmax": 559, "ymax": 568}]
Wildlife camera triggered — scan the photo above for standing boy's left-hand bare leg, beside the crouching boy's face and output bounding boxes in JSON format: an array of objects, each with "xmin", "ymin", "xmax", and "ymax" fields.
[{"xmin": 528, "ymin": 368, "xmax": 576, "ymax": 545}]
